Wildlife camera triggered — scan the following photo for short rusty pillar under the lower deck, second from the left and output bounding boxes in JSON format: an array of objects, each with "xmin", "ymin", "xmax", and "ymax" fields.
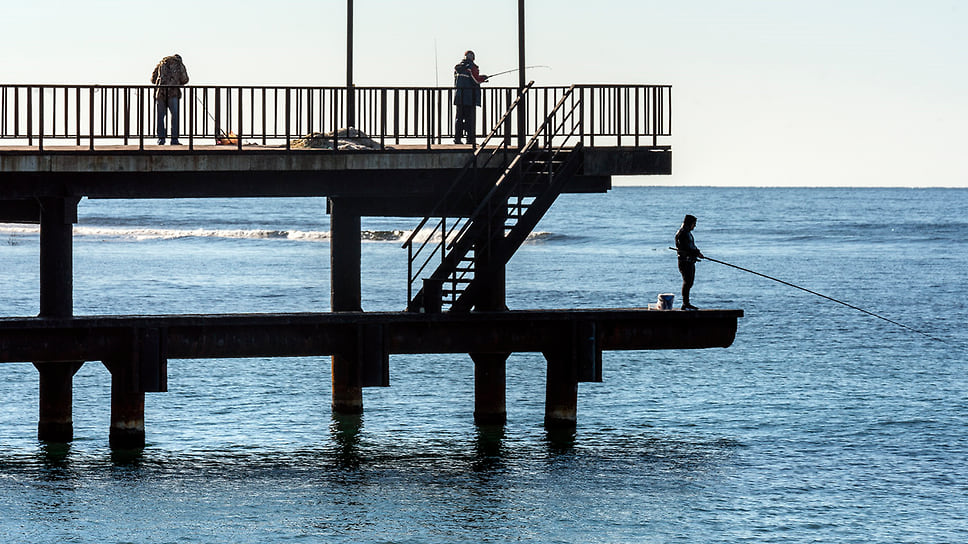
[{"xmin": 104, "ymin": 361, "xmax": 145, "ymax": 450}]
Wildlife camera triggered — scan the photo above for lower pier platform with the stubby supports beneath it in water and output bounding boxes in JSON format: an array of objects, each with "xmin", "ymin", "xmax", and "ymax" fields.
[{"xmin": 0, "ymin": 309, "xmax": 743, "ymax": 448}]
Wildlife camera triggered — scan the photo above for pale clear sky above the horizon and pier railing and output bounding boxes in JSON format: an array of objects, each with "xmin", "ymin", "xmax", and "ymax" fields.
[{"xmin": 0, "ymin": 0, "xmax": 968, "ymax": 187}]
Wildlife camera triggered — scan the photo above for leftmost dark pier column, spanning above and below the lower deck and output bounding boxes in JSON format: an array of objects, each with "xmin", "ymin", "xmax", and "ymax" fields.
[{"xmin": 34, "ymin": 197, "xmax": 83, "ymax": 442}]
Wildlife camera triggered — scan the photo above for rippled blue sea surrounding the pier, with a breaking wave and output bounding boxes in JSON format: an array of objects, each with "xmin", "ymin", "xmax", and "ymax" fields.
[{"xmin": 0, "ymin": 187, "xmax": 968, "ymax": 544}]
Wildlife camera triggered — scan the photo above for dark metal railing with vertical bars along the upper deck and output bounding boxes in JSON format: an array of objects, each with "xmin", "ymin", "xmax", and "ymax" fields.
[{"xmin": 0, "ymin": 84, "xmax": 672, "ymax": 152}]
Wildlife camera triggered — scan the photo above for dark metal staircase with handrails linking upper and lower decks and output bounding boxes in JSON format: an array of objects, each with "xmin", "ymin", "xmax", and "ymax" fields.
[{"xmin": 404, "ymin": 84, "xmax": 582, "ymax": 312}]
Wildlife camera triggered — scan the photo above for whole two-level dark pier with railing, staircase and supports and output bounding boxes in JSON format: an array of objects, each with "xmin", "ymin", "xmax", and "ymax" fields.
[{"xmin": 0, "ymin": 84, "xmax": 743, "ymax": 448}]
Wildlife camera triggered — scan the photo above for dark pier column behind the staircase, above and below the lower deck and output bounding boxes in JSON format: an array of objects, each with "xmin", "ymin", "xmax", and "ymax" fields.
[{"xmin": 470, "ymin": 242, "xmax": 510, "ymax": 425}]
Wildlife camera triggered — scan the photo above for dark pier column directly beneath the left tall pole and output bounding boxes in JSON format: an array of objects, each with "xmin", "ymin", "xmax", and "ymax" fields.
[{"xmin": 327, "ymin": 198, "xmax": 363, "ymax": 415}]
